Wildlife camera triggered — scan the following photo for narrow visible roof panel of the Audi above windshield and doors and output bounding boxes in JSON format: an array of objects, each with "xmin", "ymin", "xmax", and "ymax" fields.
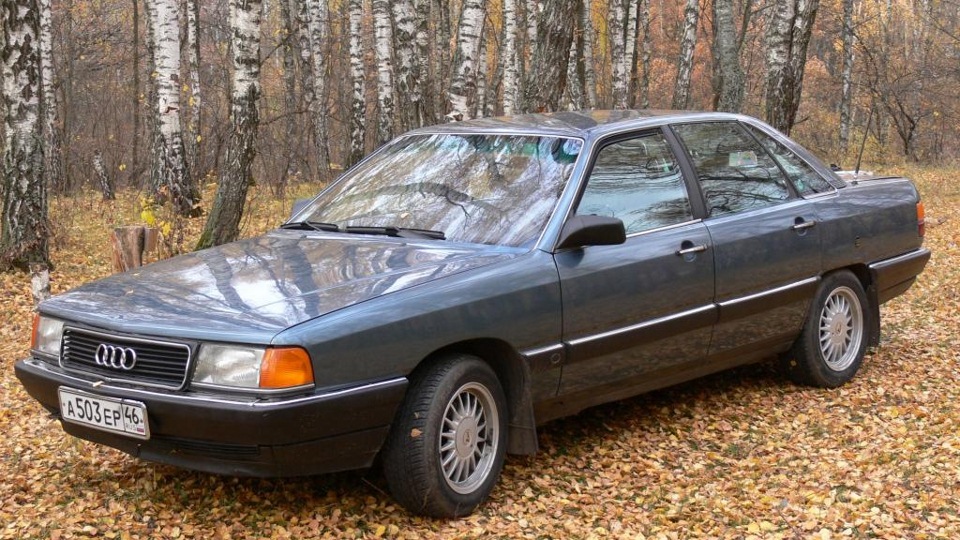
[{"xmin": 410, "ymin": 109, "xmax": 749, "ymax": 139}]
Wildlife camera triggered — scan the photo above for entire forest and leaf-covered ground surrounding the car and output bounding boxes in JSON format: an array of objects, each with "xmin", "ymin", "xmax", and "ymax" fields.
[{"xmin": 0, "ymin": 0, "xmax": 960, "ymax": 540}]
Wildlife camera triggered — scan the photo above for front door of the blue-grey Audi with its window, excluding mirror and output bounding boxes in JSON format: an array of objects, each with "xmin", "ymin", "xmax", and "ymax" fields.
[{"xmin": 555, "ymin": 130, "xmax": 716, "ymax": 405}]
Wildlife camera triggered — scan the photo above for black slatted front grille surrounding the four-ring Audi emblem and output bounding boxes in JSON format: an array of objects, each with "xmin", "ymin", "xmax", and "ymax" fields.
[{"xmin": 60, "ymin": 328, "xmax": 190, "ymax": 388}]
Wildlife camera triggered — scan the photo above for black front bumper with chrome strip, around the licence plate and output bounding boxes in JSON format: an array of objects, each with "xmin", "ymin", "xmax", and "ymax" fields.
[{"xmin": 14, "ymin": 358, "xmax": 407, "ymax": 477}]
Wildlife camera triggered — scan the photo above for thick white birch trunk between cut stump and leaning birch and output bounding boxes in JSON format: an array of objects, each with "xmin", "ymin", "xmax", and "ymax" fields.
[{"xmin": 147, "ymin": 0, "xmax": 199, "ymax": 215}]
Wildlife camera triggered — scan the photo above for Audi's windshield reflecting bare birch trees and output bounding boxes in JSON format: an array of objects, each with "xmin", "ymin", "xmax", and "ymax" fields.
[{"xmin": 295, "ymin": 134, "xmax": 582, "ymax": 246}]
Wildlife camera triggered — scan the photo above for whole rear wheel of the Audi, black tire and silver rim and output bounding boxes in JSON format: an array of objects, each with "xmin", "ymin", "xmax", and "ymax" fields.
[{"xmin": 782, "ymin": 270, "xmax": 871, "ymax": 388}]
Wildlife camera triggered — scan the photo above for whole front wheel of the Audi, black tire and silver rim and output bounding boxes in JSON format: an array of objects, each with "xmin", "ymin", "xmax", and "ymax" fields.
[{"xmin": 382, "ymin": 355, "xmax": 507, "ymax": 518}]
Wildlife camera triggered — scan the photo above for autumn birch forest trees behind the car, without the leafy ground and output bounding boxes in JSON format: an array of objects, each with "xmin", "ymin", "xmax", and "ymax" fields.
[{"xmin": 0, "ymin": 0, "xmax": 960, "ymax": 282}]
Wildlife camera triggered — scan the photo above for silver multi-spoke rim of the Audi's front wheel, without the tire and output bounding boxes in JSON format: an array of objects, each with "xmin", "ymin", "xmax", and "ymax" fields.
[{"xmin": 440, "ymin": 383, "xmax": 500, "ymax": 494}]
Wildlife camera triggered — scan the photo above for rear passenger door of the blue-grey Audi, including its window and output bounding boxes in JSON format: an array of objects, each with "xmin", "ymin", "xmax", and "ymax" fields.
[{"xmin": 672, "ymin": 121, "xmax": 820, "ymax": 361}]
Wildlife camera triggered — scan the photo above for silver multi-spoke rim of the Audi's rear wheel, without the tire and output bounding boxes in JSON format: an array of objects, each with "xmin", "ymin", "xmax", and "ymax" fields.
[{"xmin": 820, "ymin": 287, "xmax": 863, "ymax": 371}]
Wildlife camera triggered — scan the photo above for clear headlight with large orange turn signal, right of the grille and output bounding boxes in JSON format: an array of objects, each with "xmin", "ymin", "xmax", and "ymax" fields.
[{"xmin": 193, "ymin": 343, "xmax": 313, "ymax": 390}]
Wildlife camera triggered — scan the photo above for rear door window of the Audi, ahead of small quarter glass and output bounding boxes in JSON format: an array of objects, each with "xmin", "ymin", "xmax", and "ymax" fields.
[{"xmin": 673, "ymin": 122, "xmax": 791, "ymax": 216}]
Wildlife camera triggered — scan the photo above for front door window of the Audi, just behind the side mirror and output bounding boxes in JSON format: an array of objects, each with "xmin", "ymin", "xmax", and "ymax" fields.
[{"xmin": 577, "ymin": 132, "xmax": 693, "ymax": 234}]
